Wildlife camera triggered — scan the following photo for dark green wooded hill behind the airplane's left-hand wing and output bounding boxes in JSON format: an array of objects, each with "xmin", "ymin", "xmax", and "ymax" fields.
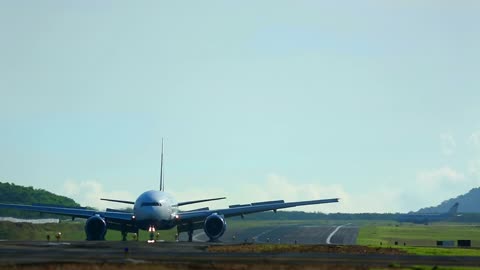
[{"xmin": 0, "ymin": 182, "xmax": 80, "ymax": 218}]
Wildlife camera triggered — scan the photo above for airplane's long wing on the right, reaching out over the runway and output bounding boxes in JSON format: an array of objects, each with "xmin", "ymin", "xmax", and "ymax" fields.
[{"xmin": 176, "ymin": 198, "xmax": 338, "ymax": 224}]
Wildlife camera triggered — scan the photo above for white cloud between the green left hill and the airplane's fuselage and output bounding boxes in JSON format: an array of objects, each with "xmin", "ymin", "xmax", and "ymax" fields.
[{"xmin": 63, "ymin": 180, "xmax": 136, "ymax": 210}]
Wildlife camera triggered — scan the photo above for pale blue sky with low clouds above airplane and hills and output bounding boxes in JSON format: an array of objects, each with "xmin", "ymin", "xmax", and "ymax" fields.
[{"xmin": 0, "ymin": 0, "xmax": 480, "ymax": 213}]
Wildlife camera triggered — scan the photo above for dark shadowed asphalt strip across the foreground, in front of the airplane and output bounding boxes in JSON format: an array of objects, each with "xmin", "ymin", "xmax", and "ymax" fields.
[{"xmin": 0, "ymin": 241, "xmax": 480, "ymax": 269}]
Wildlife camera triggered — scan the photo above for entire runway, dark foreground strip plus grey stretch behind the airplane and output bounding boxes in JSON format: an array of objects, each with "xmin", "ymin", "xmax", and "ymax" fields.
[{"xmin": 0, "ymin": 220, "xmax": 480, "ymax": 270}]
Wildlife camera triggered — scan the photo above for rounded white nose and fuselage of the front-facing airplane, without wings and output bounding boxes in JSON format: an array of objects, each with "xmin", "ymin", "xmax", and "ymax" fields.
[{"xmin": 133, "ymin": 190, "xmax": 178, "ymax": 230}]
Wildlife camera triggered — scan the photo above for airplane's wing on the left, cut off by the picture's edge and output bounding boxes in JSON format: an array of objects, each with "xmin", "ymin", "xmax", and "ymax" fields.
[{"xmin": 0, "ymin": 203, "xmax": 134, "ymax": 223}]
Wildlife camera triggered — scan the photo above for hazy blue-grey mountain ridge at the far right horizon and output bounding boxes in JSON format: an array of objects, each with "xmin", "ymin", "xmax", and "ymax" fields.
[{"xmin": 417, "ymin": 187, "xmax": 480, "ymax": 213}]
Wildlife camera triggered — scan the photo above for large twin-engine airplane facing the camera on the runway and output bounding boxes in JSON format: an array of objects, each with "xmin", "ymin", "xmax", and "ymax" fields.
[{"xmin": 0, "ymin": 140, "xmax": 339, "ymax": 242}]
